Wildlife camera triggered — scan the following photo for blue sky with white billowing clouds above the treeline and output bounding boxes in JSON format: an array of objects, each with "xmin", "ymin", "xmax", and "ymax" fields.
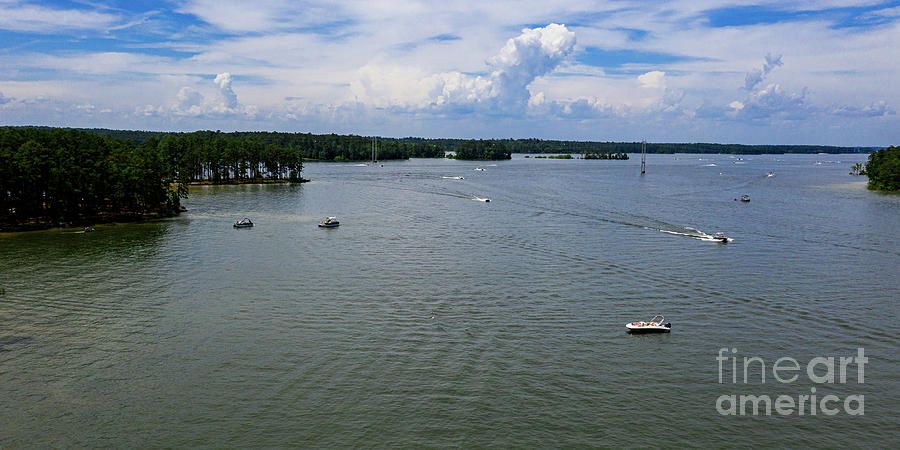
[{"xmin": 0, "ymin": 0, "xmax": 900, "ymax": 146}]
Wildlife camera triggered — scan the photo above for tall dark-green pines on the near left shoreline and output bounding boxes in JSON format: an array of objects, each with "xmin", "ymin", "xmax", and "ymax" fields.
[{"xmin": 0, "ymin": 127, "xmax": 302, "ymax": 230}]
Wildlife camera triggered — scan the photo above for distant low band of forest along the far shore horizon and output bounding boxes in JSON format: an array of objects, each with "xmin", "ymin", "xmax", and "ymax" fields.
[{"xmin": 72, "ymin": 129, "xmax": 874, "ymax": 156}]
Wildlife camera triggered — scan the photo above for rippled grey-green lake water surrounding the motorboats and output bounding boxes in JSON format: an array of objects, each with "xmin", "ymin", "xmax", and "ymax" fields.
[{"xmin": 0, "ymin": 155, "xmax": 900, "ymax": 448}]
